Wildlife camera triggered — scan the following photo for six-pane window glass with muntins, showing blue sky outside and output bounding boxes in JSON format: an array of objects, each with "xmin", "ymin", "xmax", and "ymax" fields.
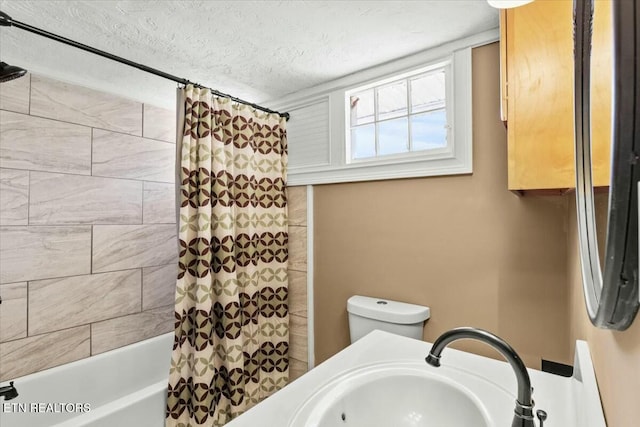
[{"xmin": 345, "ymin": 63, "xmax": 451, "ymax": 163}]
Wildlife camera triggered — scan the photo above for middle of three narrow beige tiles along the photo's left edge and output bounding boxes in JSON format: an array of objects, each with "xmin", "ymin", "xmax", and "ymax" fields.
[{"xmin": 0, "ymin": 169, "xmax": 29, "ymax": 225}]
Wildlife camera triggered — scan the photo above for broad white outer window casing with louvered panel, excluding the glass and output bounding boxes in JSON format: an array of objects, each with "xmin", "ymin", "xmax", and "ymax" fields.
[{"xmin": 265, "ymin": 29, "xmax": 499, "ymax": 185}]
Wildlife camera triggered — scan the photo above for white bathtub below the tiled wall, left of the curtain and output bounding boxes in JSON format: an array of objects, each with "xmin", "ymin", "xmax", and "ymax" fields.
[{"xmin": 0, "ymin": 332, "xmax": 173, "ymax": 427}]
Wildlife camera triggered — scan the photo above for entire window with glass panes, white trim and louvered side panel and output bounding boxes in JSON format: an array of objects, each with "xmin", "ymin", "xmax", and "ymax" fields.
[{"xmin": 269, "ymin": 30, "xmax": 499, "ymax": 185}]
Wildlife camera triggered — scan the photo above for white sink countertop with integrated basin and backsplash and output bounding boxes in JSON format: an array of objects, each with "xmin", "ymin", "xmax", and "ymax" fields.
[{"xmin": 227, "ymin": 331, "xmax": 606, "ymax": 427}]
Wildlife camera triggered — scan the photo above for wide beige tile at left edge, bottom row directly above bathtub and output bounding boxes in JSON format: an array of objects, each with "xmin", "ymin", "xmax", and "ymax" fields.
[{"xmin": 0, "ymin": 325, "xmax": 91, "ymax": 381}]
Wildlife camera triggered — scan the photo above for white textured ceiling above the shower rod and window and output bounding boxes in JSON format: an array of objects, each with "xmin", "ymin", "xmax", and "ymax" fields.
[{"xmin": 0, "ymin": 0, "xmax": 498, "ymax": 106}]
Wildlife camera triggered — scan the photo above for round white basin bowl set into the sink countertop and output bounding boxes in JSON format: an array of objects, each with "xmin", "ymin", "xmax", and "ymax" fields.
[{"xmin": 289, "ymin": 364, "xmax": 495, "ymax": 427}]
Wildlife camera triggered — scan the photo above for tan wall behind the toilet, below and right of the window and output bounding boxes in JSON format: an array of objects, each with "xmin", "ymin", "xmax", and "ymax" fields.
[{"xmin": 314, "ymin": 44, "xmax": 572, "ymax": 368}]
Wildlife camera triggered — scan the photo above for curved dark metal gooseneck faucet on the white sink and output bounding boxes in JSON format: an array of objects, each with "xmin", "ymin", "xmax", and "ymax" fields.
[{"xmin": 425, "ymin": 328, "xmax": 546, "ymax": 427}]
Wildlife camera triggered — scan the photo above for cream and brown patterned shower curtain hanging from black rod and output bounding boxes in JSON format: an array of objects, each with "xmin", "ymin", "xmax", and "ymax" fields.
[{"xmin": 166, "ymin": 85, "xmax": 289, "ymax": 427}]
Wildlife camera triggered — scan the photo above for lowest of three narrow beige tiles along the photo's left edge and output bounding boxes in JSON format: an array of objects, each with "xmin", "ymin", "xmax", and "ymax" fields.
[{"xmin": 0, "ymin": 282, "xmax": 27, "ymax": 342}]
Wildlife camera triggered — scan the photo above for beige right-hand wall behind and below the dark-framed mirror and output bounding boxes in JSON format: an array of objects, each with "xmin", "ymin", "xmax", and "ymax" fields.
[{"xmin": 567, "ymin": 194, "xmax": 640, "ymax": 427}]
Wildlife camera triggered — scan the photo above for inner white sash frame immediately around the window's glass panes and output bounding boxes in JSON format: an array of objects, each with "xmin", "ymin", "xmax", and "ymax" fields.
[{"xmin": 344, "ymin": 58, "xmax": 455, "ymax": 165}]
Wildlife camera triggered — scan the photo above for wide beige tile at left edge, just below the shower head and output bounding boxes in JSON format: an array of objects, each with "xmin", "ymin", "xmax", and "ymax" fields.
[{"xmin": 0, "ymin": 111, "xmax": 91, "ymax": 175}]
